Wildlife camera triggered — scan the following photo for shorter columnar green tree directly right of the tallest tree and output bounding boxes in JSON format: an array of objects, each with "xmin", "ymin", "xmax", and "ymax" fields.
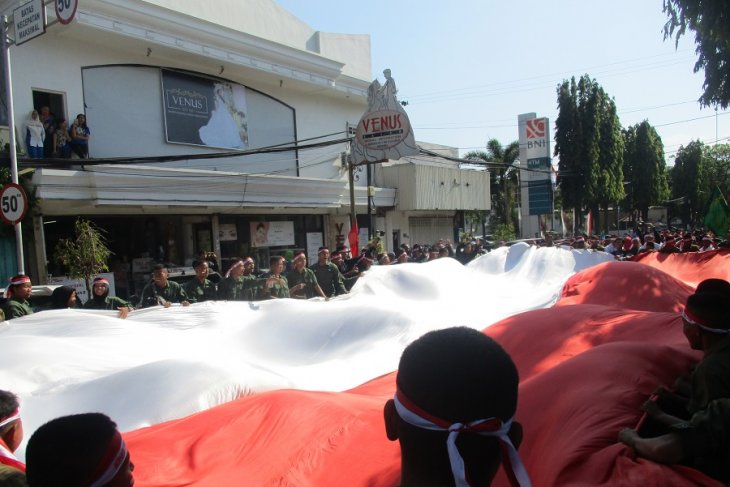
[{"xmin": 623, "ymin": 120, "xmax": 669, "ymax": 220}]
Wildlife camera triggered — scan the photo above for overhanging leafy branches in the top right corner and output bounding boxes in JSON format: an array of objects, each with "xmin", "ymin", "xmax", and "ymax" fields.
[{"xmin": 663, "ymin": 0, "xmax": 730, "ymax": 108}]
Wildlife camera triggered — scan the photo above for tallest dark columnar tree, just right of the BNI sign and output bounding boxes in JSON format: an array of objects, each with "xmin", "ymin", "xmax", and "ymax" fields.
[{"xmin": 554, "ymin": 75, "xmax": 624, "ymax": 234}]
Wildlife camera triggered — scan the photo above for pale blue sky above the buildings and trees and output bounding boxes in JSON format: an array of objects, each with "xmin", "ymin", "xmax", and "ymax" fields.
[{"xmin": 277, "ymin": 0, "xmax": 730, "ymax": 164}]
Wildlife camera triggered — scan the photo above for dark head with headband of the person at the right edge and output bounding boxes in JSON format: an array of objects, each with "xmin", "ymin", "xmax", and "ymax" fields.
[{"xmin": 682, "ymin": 279, "xmax": 730, "ymax": 350}]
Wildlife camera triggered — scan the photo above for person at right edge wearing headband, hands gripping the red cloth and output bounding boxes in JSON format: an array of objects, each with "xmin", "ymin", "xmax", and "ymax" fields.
[{"xmin": 618, "ymin": 279, "xmax": 730, "ymax": 484}]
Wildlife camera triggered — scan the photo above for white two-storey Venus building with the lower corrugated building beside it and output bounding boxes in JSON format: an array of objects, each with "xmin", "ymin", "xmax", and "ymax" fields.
[{"xmin": 0, "ymin": 0, "xmax": 489, "ymax": 290}]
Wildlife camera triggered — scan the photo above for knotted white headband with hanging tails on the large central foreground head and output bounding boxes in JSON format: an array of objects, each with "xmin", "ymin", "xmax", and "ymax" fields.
[{"xmin": 393, "ymin": 396, "xmax": 532, "ymax": 487}]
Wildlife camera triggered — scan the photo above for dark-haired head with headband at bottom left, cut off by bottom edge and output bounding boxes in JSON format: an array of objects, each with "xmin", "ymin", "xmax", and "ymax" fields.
[{"xmin": 25, "ymin": 413, "xmax": 134, "ymax": 487}]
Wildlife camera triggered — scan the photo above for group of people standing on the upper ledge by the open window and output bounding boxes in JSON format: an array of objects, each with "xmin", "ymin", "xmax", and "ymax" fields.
[{"xmin": 25, "ymin": 106, "xmax": 91, "ymax": 159}]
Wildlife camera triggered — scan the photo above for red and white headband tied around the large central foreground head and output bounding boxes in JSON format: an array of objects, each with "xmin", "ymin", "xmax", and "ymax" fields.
[{"xmin": 394, "ymin": 390, "xmax": 532, "ymax": 487}]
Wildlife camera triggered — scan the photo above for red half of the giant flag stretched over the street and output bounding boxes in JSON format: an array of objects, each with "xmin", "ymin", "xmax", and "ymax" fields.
[{"xmin": 125, "ymin": 255, "xmax": 727, "ymax": 487}]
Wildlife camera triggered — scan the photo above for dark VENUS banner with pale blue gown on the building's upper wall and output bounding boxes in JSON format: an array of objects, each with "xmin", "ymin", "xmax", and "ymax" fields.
[{"xmin": 162, "ymin": 69, "xmax": 249, "ymax": 149}]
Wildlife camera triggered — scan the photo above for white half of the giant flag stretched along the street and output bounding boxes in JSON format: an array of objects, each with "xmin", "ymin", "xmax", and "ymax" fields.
[{"xmin": 0, "ymin": 244, "xmax": 613, "ymax": 456}]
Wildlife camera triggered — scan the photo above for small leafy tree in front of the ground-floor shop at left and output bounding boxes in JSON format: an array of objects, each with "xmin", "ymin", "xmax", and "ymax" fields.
[{"xmin": 55, "ymin": 218, "xmax": 112, "ymax": 296}]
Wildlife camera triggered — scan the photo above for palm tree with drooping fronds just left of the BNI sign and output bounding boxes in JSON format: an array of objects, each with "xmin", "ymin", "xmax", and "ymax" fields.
[{"xmin": 464, "ymin": 139, "xmax": 520, "ymax": 232}]
